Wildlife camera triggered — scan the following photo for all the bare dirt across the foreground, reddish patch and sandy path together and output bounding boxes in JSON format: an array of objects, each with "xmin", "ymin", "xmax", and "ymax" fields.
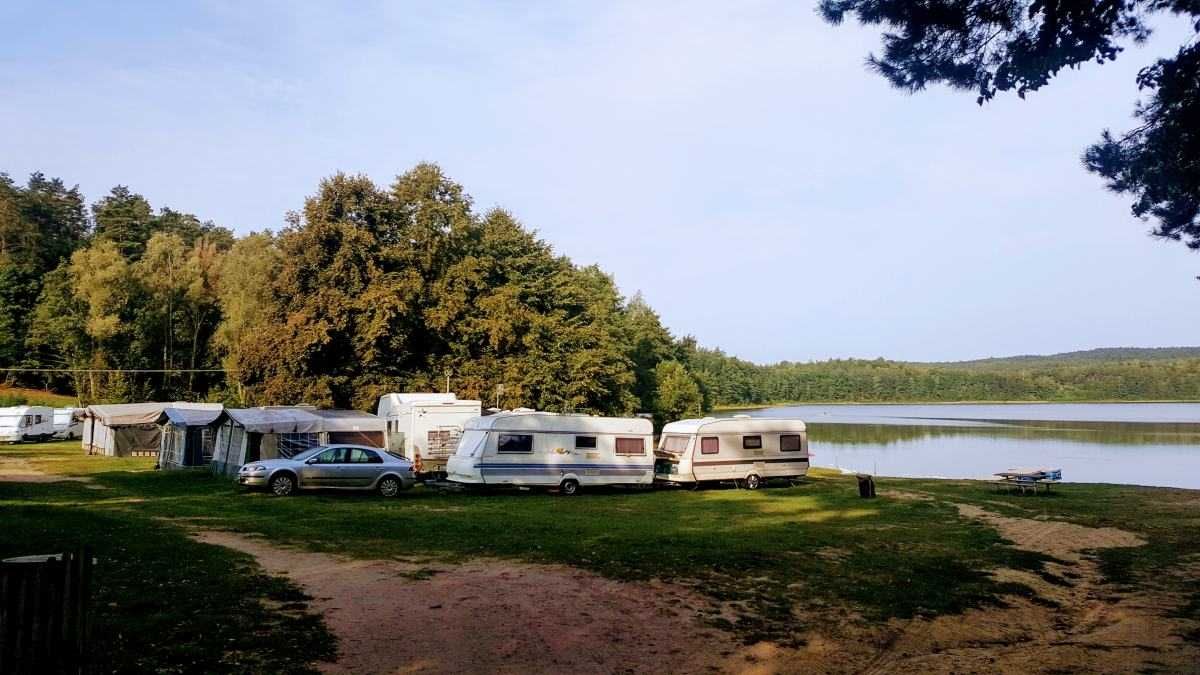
[{"xmin": 197, "ymin": 497, "xmax": 1200, "ymax": 674}]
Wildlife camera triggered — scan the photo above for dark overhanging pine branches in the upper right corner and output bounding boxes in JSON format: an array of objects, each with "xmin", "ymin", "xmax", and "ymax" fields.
[{"xmin": 820, "ymin": 0, "xmax": 1200, "ymax": 249}]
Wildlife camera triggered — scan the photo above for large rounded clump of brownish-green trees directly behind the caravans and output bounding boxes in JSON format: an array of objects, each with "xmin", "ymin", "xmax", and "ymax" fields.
[{"xmin": 220, "ymin": 165, "xmax": 665, "ymax": 413}]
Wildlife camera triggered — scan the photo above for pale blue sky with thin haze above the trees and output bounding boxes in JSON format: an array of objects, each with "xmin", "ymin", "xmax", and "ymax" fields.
[{"xmin": 0, "ymin": 0, "xmax": 1200, "ymax": 362}]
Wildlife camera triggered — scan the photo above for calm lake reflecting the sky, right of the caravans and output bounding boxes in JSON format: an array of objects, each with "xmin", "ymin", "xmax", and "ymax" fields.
[{"xmin": 721, "ymin": 404, "xmax": 1200, "ymax": 489}]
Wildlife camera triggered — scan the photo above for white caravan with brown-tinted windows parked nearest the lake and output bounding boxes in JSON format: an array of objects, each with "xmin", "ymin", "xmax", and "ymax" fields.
[{"xmin": 654, "ymin": 414, "xmax": 809, "ymax": 490}]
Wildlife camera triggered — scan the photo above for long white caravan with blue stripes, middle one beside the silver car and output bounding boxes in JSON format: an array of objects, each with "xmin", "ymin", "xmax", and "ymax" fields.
[{"xmin": 446, "ymin": 411, "xmax": 654, "ymax": 495}]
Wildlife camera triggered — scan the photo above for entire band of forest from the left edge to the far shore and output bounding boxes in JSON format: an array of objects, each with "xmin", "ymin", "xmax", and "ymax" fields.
[{"xmin": 0, "ymin": 163, "xmax": 1200, "ymax": 423}]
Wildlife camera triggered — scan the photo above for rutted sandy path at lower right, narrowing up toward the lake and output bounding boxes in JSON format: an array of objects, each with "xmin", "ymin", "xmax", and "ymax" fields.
[{"xmin": 757, "ymin": 504, "xmax": 1200, "ymax": 674}]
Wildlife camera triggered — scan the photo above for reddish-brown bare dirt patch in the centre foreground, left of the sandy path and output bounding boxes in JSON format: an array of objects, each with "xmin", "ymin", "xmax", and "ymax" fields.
[{"xmin": 196, "ymin": 531, "xmax": 750, "ymax": 673}]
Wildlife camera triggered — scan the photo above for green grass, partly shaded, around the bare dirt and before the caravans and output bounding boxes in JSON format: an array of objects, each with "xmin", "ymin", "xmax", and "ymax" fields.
[{"xmin": 0, "ymin": 443, "xmax": 1200, "ymax": 673}]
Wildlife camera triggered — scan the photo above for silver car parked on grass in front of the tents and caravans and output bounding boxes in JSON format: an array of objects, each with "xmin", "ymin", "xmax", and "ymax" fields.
[{"xmin": 238, "ymin": 446, "xmax": 416, "ymax": 497}]
